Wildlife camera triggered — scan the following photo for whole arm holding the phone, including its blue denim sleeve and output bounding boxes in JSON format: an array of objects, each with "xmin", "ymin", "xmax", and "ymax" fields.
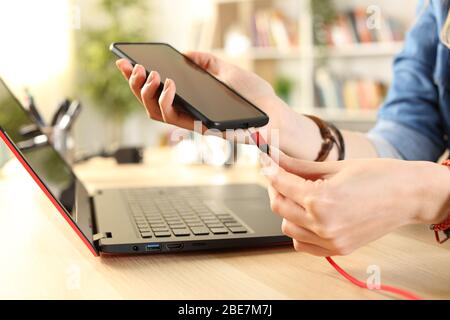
[{"xmin": 117, "ymin": 0, "xmax": 444, "ymax": 160}]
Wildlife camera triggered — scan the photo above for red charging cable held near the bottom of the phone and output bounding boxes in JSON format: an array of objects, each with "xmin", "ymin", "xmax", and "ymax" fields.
[{"xmin": 249, "ymin": 129, "xmax": 422, "ymax": 300}]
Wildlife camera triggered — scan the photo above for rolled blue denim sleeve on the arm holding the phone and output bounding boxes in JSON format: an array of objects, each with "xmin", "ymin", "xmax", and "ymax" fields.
[{"xmin": 368, "ymin": 2, "xmax": 445, "ymax": 161}]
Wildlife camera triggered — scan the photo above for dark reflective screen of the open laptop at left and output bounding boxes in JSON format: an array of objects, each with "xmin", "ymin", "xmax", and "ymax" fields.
[{"xmin": 0, "ymin": 79, "xmax": 96, "ymax": 252}]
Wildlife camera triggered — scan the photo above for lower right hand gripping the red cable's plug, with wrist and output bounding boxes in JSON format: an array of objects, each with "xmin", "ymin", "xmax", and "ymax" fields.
[{"xmin": 262, "ymin": 153, "xmax": 450, "ymax": 256}]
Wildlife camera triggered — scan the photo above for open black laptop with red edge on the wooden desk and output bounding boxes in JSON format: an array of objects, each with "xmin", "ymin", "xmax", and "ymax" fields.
[{"xmin": 0, "ymin": 79, "xmax": 290, "ymax": 256}]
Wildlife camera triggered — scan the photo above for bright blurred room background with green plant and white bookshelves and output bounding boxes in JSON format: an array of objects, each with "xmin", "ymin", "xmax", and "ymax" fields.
[{"xmin": 0, "ymin": 0, "xmax": 417, "ymax": 168}]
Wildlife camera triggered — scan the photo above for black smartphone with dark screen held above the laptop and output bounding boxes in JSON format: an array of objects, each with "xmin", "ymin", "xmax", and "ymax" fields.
[{"xmin": 110, "ymin": 42, "xmax": 269, "ymax": 131}]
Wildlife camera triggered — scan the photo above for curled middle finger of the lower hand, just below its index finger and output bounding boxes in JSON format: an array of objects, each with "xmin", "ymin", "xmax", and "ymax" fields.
[{"xmin": 268, "ymin": 185, "xmax": 314, "ymax": 229}]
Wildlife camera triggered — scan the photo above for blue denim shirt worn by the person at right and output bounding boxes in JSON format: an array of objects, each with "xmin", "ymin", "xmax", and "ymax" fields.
[{"xmin": 368, "ymin": 0, "xmax": 450, "ymax": 161}]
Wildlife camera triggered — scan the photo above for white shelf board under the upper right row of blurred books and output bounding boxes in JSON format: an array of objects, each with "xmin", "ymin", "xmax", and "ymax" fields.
[{"xmin": 314, "ymin": 41, "xmax": 403, "ymax": 59}]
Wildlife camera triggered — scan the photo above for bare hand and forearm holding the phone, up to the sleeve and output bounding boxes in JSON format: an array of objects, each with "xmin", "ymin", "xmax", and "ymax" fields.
[{"xmin": 117, "ymin": 52, "xmax": 376, "ymax": 160}]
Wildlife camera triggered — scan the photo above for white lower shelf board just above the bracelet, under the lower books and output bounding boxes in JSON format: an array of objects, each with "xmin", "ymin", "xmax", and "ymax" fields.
[{"xmin": 293, "ymin": 107, "xmax": 378, "ymax": 123}]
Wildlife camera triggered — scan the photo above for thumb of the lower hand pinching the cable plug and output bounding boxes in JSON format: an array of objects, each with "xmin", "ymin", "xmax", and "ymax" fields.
[{"xmin": 270, "ymin": 147, "xmax": 341, "ymax": 180}]
